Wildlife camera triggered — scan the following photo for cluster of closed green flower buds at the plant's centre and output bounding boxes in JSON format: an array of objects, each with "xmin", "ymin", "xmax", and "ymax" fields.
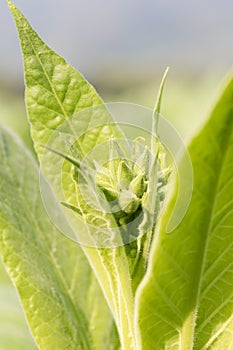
[{"xmin": 95, "ymin": 139, "xmax": 168, "ymax": 235}]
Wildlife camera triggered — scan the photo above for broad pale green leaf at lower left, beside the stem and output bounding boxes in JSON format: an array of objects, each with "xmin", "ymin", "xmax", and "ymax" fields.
[{"xmin": 0, "ymin": 128, "xmax": 118, "ymax": 350}]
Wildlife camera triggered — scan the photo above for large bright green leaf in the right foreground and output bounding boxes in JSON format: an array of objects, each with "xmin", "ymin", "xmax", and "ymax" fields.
[{"xmin": 138, "ymin": 77, "xmax": 233, "ymax": 350}]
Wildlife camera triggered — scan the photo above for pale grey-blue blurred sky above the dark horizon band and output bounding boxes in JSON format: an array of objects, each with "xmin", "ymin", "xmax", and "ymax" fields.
[{"xmin": 0, "ymin": 0, "xmax": 233, "ymax": 83}]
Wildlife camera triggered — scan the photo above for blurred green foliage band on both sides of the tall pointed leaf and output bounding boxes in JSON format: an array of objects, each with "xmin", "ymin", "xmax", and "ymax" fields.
[{"xmin": 0, "ymin": 74, "xmax": 220, "ymax": 150}]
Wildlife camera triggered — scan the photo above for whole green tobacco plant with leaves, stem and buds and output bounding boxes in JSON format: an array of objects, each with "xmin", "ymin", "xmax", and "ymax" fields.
[{"xmin": 0, "ymin": 1, "xmax": 233, "ymax": 350}]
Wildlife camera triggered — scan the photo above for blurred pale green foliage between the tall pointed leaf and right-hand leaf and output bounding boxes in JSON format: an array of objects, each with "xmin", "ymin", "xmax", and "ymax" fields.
[{"xmin": 98, "ymin": 73, "xmax": 221, "ymax": 142}]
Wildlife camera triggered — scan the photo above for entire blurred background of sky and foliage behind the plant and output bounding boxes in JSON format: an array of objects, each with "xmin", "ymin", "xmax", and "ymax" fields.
[{"xmin": 0, "ymin": 0, "xmax": 233, "ymax": 350}]
